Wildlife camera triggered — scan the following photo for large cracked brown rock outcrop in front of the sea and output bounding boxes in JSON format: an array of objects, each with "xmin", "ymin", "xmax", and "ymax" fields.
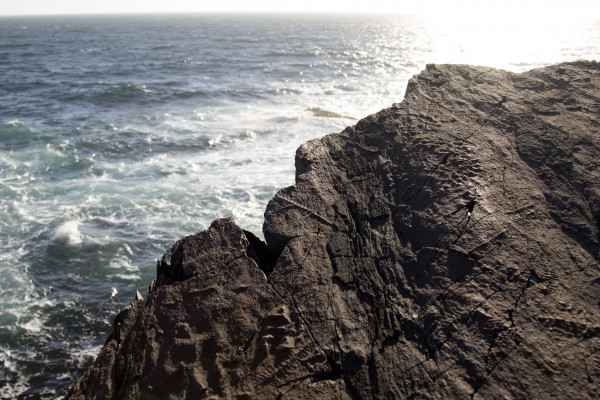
[{"xmin": 67, "ymin": 62, "xmax": 600, "ymax": 399}]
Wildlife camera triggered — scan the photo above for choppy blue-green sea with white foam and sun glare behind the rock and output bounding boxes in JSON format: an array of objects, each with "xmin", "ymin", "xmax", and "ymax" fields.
[{"xmin": 0, "ymin": 14, "xmax": 600, "ymax": 399}]
